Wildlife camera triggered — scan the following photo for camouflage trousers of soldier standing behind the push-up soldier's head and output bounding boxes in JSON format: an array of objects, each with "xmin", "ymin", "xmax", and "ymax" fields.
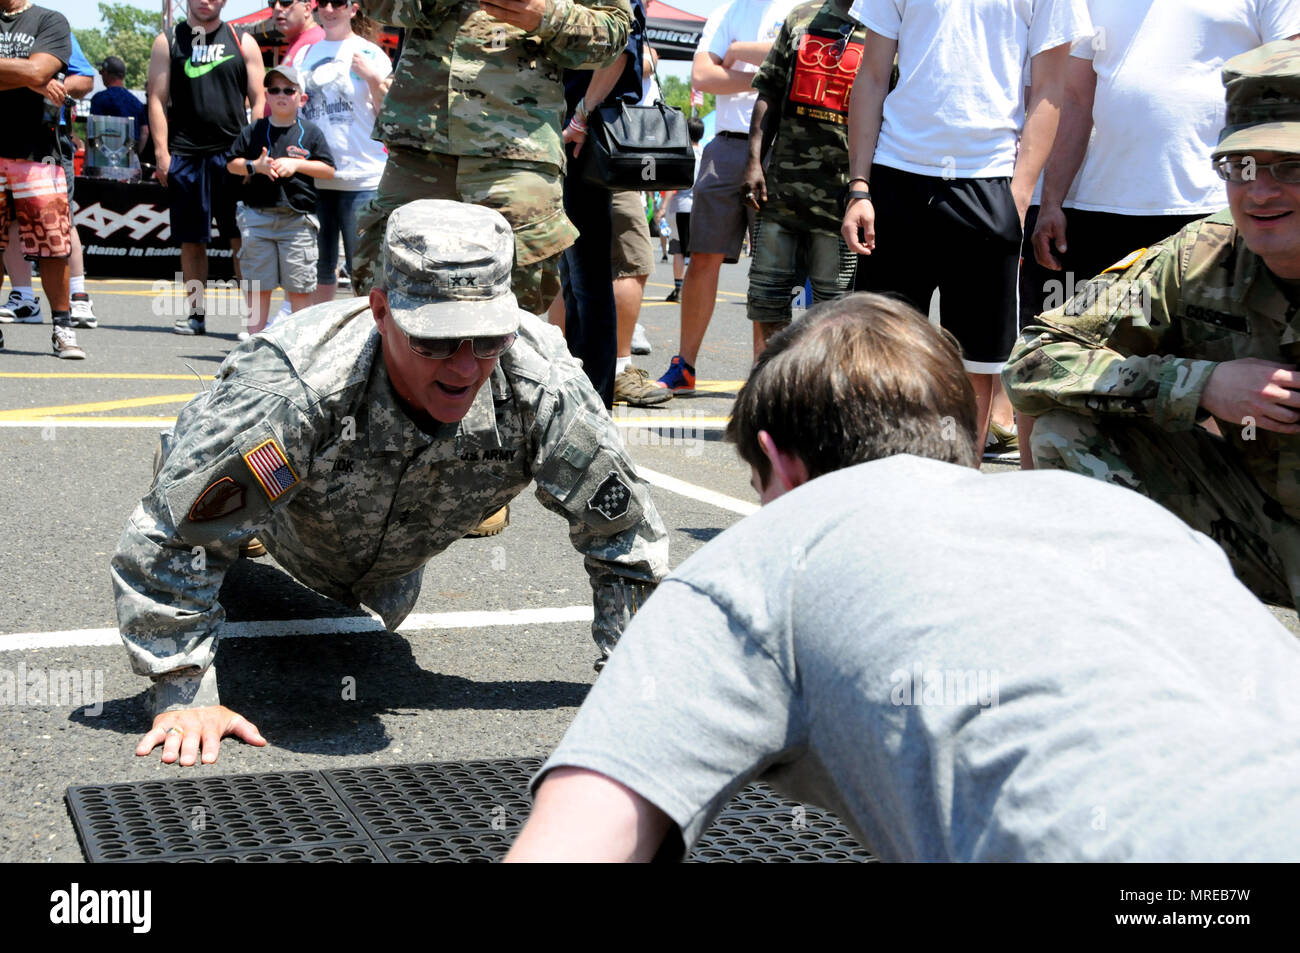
[{"xmin": 352, "ymin": 147, "xmax": 577, "ymax": 315}]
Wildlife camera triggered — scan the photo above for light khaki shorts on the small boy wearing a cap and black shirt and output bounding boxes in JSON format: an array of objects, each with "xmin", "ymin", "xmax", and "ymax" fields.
[{"xmin": 235, "ymin": 203, "xmax": 320, "ymax": 294}]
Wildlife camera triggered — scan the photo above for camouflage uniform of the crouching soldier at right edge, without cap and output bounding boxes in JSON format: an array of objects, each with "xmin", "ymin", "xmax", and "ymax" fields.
[{"xmin": 1002, "ymin": 211, "xmax": 1300, "ymax": 605}]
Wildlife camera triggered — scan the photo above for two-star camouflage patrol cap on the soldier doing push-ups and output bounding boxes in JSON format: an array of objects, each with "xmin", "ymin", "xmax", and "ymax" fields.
[{"xmin": 384, "ymin": 199, "xmax": 519, "ymax": 338}]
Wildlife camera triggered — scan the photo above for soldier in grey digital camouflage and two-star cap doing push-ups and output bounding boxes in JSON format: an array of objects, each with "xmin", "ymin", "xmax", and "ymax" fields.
[{"xmin": 112, "ymin": 200, "xmax": 668, "ymax": 764}]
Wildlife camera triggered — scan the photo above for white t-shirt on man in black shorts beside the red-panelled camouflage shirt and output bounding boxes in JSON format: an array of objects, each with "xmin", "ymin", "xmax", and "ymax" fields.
[{"xmin": 849, "ymin": 0, "xmax": 1092, "ymax": 178}]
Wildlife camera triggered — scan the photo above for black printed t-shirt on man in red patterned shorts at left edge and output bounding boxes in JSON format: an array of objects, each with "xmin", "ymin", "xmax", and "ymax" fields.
[{"xmin": 0, "ymin": 7, "xmax": 73, "ymax": 163}]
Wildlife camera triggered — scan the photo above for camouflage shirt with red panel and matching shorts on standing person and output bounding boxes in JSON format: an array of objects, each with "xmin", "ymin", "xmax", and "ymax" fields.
[{"xmin": 748, "ymin": 0, "xmax": 867, "ymax": 321}]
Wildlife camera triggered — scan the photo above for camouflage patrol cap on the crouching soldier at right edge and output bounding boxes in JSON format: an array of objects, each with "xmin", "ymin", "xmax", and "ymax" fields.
[{"xmin": 1213, "ymin": 40, "xmax": 1300, "ymax": 159}]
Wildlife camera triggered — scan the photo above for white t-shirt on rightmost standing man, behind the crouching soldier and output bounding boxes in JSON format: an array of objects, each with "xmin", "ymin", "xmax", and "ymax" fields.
[{"xmin": 1063, "ymin": 0, "xmax": 1300, "ymax": 215}]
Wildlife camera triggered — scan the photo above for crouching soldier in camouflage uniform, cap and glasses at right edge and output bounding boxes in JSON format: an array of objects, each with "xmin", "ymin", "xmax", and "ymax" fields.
[{"xmin": 1002, "ymin": 40, "xmax": 1300, "ymax": 605}]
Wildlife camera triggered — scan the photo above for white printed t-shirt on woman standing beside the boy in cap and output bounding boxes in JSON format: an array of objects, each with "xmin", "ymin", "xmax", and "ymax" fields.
[{"xmin": 293, "ymin": 34, "xmax": 393, "ymax": 191}]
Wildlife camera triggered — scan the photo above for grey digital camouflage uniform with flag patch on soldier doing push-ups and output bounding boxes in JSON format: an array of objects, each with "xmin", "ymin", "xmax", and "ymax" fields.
[{"xmin": 112, "ymin": 299, "xmax": 668, "ymax": 714}]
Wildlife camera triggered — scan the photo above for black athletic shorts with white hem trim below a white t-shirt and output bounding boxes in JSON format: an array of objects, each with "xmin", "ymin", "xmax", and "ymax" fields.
[{"xmin": 853, "ymin": 165, "xmax": 1022, "ymax": 374}]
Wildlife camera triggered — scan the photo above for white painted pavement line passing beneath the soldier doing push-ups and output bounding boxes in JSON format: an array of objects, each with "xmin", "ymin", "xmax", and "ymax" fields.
[{"xmin": 0, "ymin": 606, "xmax": 593, "ymax": 651}]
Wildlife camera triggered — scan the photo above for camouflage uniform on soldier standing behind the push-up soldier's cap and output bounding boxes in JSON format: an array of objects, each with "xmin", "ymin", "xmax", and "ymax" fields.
[{"xmin": 354, "ymin": 0, "xmax": 632, "ymax": 313}]
